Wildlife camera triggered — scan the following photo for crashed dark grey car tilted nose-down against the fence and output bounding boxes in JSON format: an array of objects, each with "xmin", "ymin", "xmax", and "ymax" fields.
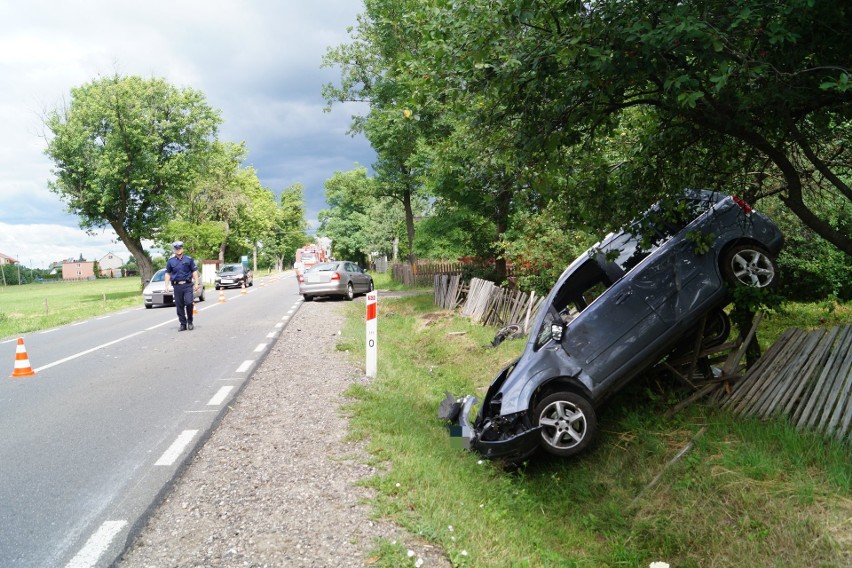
[{"xmin": 439, "ymin": 190, "xmax": 783, "ymax": 461}]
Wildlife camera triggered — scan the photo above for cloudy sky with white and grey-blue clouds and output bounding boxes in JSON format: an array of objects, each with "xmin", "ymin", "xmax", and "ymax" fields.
[{"xmin": 0, "ymin": 0, "xmax": 375, "ymax": 268}]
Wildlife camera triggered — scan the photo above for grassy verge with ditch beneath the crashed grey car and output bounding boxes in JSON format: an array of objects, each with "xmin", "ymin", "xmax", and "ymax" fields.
[{"xmin": 340, "ymin": 294, "xmax": 852, "ymax": 567}]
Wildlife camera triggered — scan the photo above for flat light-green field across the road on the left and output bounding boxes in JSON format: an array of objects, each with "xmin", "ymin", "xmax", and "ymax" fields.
[{"xmin": 0, "ymin": 278, "xmax": 142, "ymax": 339}]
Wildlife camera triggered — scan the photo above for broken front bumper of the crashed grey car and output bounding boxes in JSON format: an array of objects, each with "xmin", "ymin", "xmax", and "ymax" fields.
[{"xmin": 438, "ymin": 393, "xmax": 541, "ymax": 461}]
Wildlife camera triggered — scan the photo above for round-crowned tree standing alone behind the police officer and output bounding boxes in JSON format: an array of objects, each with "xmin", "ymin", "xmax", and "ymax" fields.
[{"xmin": 45, "ymin": 75, "xmax": 221, "ymax": 282}]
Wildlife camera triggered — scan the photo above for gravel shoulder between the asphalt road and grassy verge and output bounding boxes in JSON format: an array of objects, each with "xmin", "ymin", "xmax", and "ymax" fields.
[{"xmin": 122, "ymin": 299, "xmax": 450, "ymax": 568}]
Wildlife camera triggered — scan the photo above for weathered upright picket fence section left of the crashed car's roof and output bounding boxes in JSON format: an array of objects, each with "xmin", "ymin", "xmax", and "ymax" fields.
[{"xmin": 434, "ymin": 274, "xmax": 543, "ymax": 334}]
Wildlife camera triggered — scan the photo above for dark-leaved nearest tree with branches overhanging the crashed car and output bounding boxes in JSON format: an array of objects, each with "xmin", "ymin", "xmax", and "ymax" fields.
[{"xmin": 410, "ymin": 0, "xmax": 852, "ymax": 254}]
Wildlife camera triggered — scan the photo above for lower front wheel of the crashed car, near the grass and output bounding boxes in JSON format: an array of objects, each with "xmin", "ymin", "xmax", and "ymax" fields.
[{"xmin": 533, "ymin": 391, "xmax": 598, "ymax": 457}]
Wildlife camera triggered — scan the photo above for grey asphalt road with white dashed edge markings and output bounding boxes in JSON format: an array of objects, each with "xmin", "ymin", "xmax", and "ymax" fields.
[{"xmin": 0, "ymin": 273, "xmax": 301, "ymax": 568}]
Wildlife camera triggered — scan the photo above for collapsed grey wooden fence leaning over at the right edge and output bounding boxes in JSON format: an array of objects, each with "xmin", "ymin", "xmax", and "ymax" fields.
[{"xmin": 722, "ymin": 325, "xmax": 852, "ymax": 440}]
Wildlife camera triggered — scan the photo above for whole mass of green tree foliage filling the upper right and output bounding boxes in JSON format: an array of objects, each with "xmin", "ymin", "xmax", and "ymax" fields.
[{"xmin": 325, "ymin": 0, "xmax": 852, "ymax": 276}]
